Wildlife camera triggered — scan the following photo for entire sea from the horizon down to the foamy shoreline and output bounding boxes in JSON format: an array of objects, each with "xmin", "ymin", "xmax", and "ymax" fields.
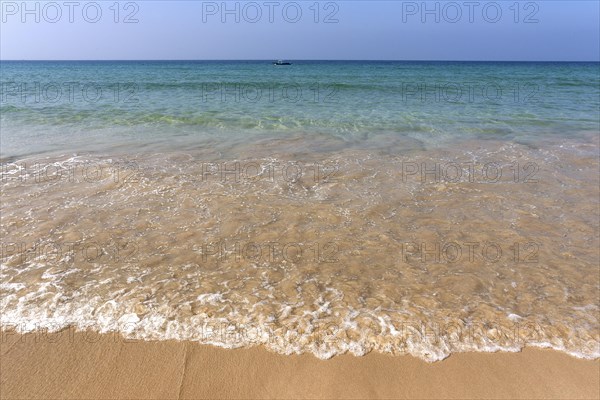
[{"xmin": 0, "ymin": 60, "xmax": 600, "ymax": 361}]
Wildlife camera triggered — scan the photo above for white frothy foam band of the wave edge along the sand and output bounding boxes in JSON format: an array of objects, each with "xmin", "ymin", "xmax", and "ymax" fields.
[{"xmin": 0, "ymin": 276, "xmax": 600, "ymax": 362}]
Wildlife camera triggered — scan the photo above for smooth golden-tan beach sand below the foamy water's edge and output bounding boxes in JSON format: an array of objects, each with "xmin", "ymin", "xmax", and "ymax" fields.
[{"xmin": 0, "ymin": 330, "xmax": 600, "ymax": 399}]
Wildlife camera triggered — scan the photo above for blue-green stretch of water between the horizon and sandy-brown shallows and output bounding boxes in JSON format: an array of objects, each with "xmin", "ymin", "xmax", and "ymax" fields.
[{"xmin": 0, "ymin": 61, "xmax": 600, "ymax": 158}]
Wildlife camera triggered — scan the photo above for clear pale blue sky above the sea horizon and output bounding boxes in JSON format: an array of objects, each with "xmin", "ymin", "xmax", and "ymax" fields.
[{"xmin": 0, "ymin": 0, "xmax": 600, "ymax": 61}]
